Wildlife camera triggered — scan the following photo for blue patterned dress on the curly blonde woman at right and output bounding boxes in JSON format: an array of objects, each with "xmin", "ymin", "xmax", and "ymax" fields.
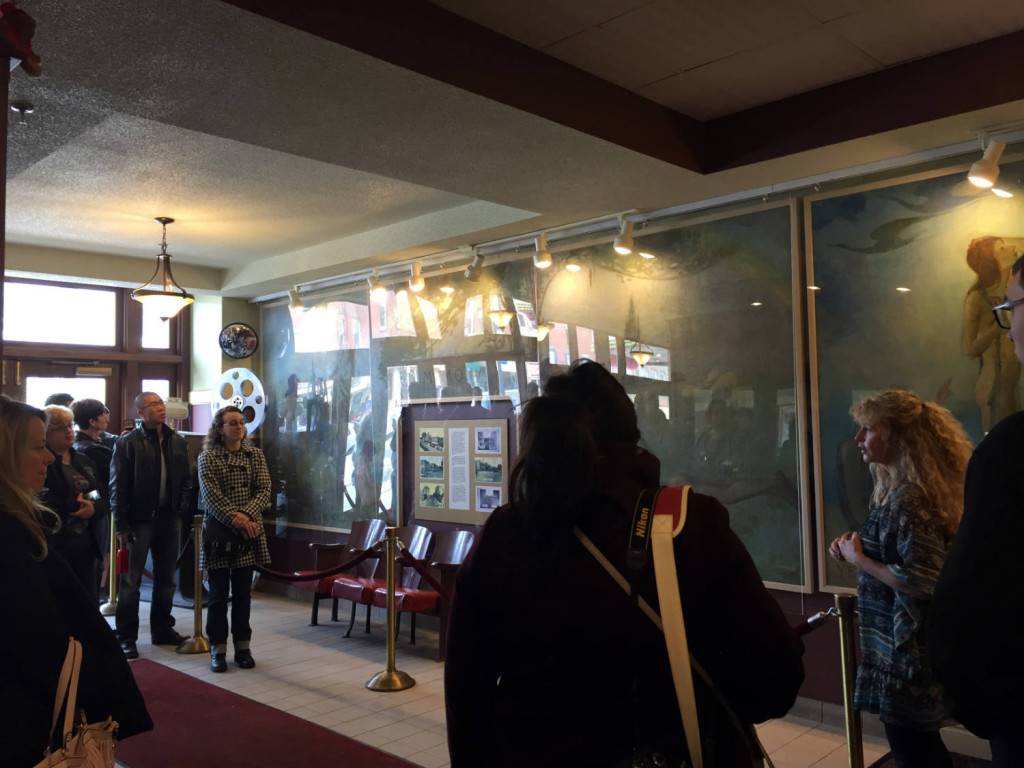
[{"xmin": 854, "ymin": 485, "xmax": 952, "ymax": 730}]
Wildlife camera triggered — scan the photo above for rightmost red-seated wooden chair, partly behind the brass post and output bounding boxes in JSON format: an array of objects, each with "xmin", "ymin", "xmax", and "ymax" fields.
[{"xmin": 374, "ymin": 530, "xmax": 474, "ymax": 662}]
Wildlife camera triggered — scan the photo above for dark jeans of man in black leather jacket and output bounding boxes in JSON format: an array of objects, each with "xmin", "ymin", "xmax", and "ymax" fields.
[{"xmin": 116, "ymin": 512, "xmax": 181, "ymax": 640}]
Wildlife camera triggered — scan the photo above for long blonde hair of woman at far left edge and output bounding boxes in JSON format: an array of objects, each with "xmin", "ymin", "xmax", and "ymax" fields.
[{"xmin": 0, "ymin": 395, "xmax": 60, "ymax": 560}]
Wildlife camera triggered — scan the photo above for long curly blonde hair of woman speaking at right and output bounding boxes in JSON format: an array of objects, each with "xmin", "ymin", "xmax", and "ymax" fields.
[{"xmin": 850, "ymin": 389, "xmax": 973, "ymax": 534}]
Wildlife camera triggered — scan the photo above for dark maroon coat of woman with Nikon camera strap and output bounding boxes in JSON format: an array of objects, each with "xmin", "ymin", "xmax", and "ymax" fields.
[{"xmin": 444, "ymin": 445, "xmax": 804, "ymax": 768}]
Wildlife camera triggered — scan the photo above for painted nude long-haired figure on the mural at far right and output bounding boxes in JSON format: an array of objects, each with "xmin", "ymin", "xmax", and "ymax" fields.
[{"xmin": 962, "ymin": 237, "xmax": 1021, "ymax": 432}]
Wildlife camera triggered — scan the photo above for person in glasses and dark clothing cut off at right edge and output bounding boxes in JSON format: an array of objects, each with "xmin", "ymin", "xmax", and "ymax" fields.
[{"xmin": 928, "ymin": 258, "xmax": 1024, "ymax": 768}]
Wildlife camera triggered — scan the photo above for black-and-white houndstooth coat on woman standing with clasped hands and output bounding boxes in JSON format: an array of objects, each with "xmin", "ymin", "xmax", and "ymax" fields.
[{"xmin": 199, "ymin": 442, "xmax": 270, "ymax": 570}]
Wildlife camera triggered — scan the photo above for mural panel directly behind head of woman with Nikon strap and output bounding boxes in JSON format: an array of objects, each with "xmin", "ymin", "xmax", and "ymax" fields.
[{"xmin": 538, "ymin": 205, "xmax": 808, "ymax": 589}]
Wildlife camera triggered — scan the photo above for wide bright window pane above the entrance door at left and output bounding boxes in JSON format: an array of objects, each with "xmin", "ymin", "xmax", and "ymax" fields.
[{"xmin": 3, "ymin": 283, "xmax": 118, "ymax": 347}]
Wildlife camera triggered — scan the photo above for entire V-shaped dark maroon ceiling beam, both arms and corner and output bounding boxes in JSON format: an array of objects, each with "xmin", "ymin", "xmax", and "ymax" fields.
[{"xmin": 222, "ymin": 0, "xmax": 1024, "ymax": 173}]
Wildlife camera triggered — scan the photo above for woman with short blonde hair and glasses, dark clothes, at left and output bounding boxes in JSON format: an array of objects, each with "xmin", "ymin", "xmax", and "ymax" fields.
[{"xmin": 44, "ymin": 406, "xmax": 110, "ymax": 605}]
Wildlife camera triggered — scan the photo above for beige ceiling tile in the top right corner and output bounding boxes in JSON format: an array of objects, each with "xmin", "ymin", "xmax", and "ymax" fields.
[{"xmin": 828, "ymin": 0, "xmax": 1024, "ymax": 67}]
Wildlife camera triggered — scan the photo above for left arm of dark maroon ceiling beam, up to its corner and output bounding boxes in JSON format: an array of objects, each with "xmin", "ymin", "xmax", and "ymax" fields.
[{"xmin": 222, "ymin": 0, "xmax": 705, "ymax": 171}]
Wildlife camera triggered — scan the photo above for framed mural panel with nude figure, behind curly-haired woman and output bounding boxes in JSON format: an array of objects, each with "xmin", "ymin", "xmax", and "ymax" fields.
[{"xmin": 804, "ymin": 161, "xmax": 1024, "ymax": 592}]
